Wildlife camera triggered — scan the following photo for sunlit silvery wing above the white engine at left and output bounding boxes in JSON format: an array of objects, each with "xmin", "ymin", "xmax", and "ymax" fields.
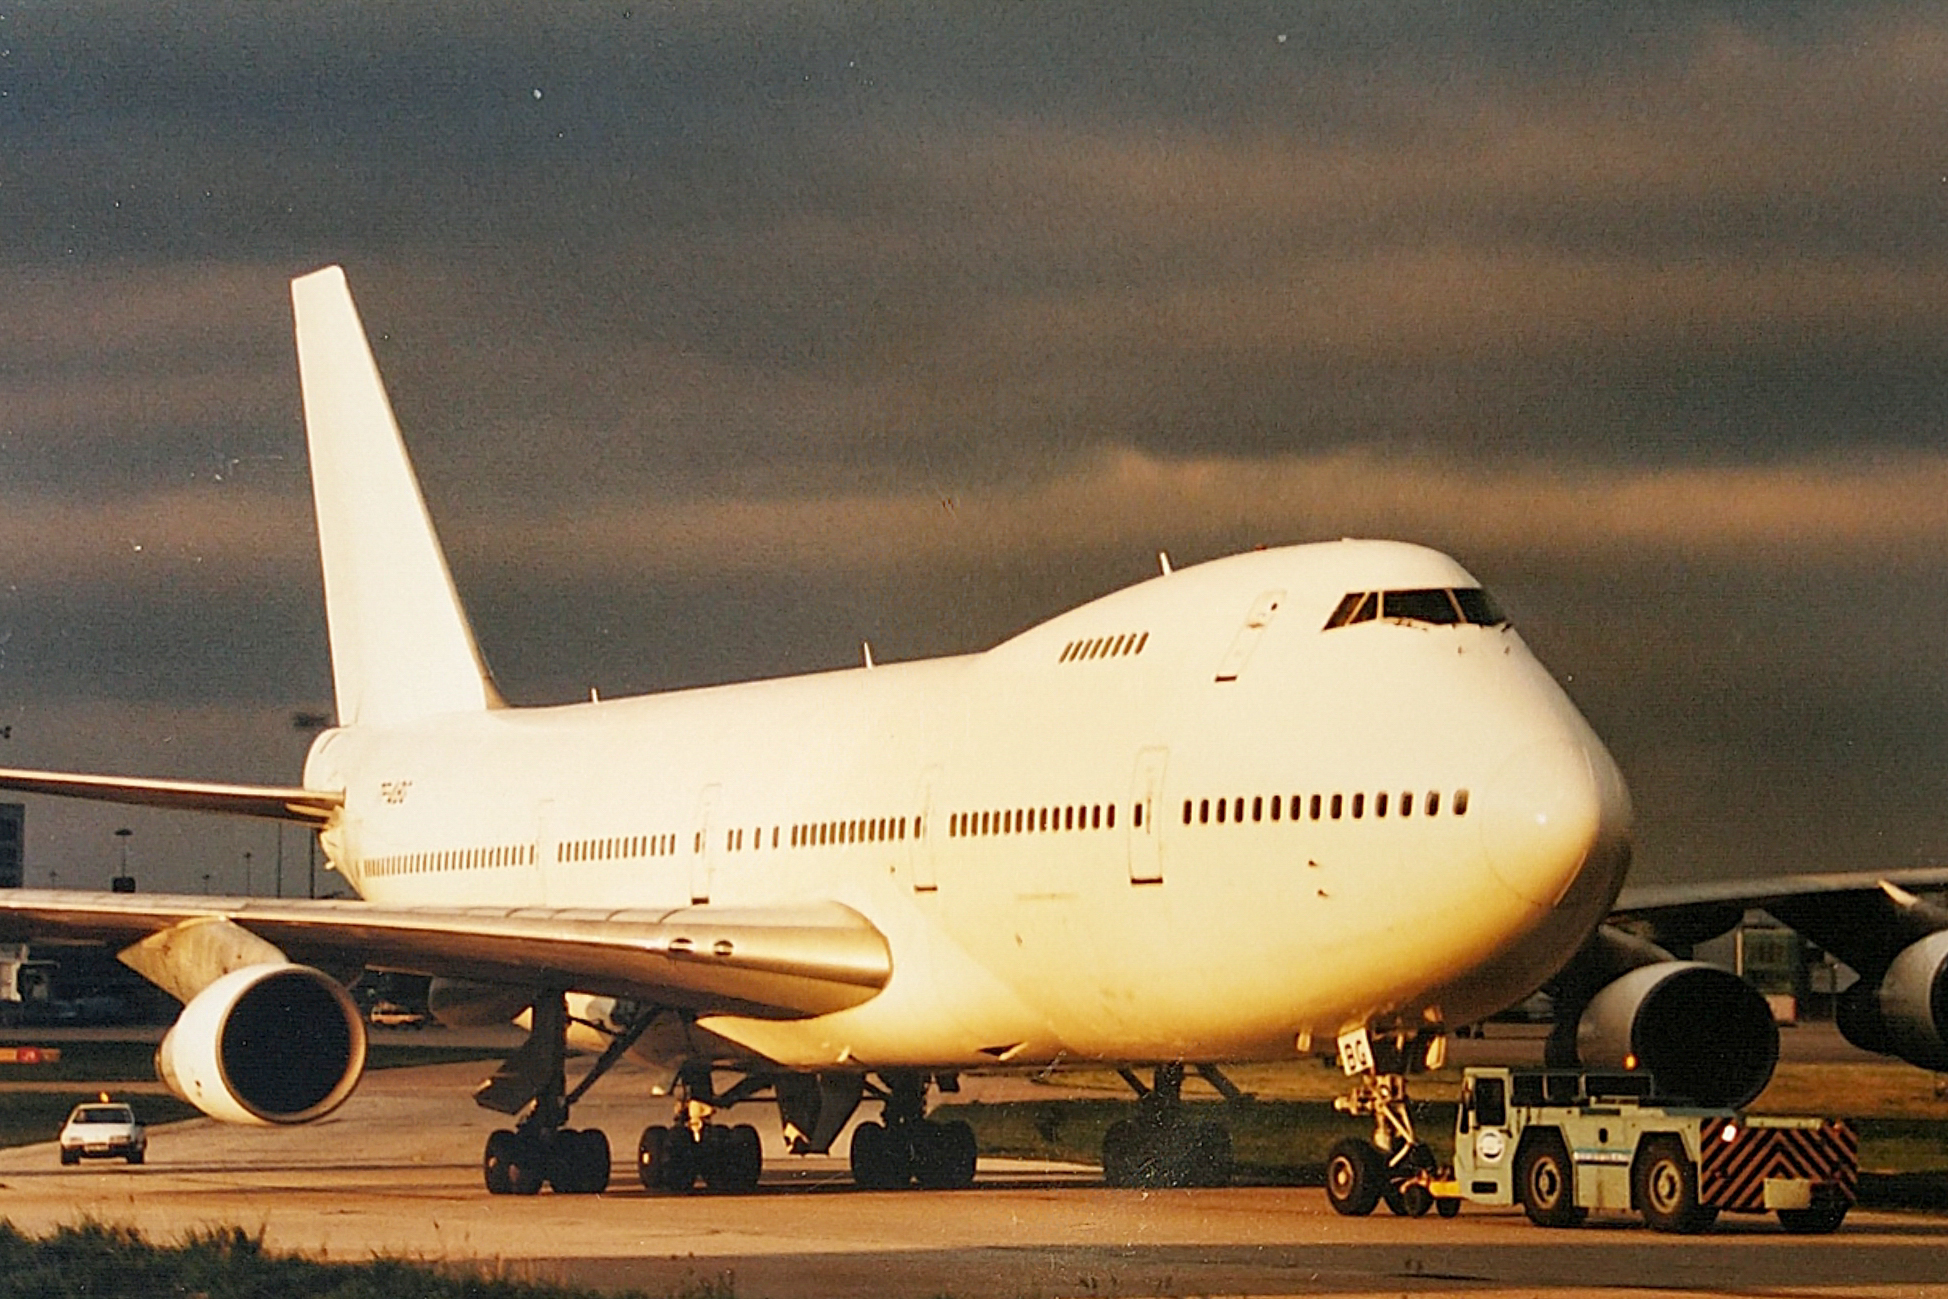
[{"xmin": 0, "ymin": 890, "xmax": 892, "ymax": 1019}]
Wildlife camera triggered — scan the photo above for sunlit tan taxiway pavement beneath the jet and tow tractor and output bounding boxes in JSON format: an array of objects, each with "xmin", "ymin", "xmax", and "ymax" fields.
[{"xmin": 0, "ymin": 1065, "xmax": 1948, "ymax": 1299}]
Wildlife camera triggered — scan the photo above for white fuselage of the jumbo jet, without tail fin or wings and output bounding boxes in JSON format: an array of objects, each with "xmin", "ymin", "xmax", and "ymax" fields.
[{"xmin": 306, "ymin": 541, "xmax": 1629, "ymax": 1069}]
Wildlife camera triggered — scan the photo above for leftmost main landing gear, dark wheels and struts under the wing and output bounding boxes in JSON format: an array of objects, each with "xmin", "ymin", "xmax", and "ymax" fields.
[{"xmin": 473, "ymin": 991, "xmax": 651, "ymax": 1196}]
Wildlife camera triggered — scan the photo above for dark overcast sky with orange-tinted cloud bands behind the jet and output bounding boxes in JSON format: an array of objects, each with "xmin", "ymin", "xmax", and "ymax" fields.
[{"xmin": 0, "ymin": 0, "xmax": 1948, "ymax": 892}]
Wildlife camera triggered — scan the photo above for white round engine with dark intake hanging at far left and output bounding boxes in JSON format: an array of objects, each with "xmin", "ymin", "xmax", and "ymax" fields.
[{"xmin": 156, "ymin": 964, "xmax": 366, "ymax": 1124}]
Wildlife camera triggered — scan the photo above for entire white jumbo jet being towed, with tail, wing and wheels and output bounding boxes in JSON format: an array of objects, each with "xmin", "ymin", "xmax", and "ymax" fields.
[{"xmin": 0, "ymin": 267, "xmax": 1706, "ymax": 1207}]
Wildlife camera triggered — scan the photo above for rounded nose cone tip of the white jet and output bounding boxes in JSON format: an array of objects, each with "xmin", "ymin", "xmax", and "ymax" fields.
[{"xmin": 1477, "ymin": 738, "xmax": 1630, "ymax": 908}]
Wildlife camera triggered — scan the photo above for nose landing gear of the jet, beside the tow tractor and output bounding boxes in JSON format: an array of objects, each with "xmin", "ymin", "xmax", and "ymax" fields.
[{"xmin": 1327, "ymin": 1030, "xmax": 1459, "ymax": 1217}]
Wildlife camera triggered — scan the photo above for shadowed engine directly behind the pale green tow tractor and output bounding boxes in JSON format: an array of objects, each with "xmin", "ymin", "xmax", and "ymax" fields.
[{"xmin": 1576, "ymin": 960, "xmax": 1779, "ymax": 1106}]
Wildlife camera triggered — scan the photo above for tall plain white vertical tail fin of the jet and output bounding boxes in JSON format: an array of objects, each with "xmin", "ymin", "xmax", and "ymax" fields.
[{"xmin": 290, "ymin": 267, "xmax": 503, "ymax": 726}]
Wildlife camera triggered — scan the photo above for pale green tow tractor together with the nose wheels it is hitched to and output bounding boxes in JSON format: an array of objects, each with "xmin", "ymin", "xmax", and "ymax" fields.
[{"xmin": 1327, "ymin": 1069, "xmax": 1858, "ymax": 1233}]
